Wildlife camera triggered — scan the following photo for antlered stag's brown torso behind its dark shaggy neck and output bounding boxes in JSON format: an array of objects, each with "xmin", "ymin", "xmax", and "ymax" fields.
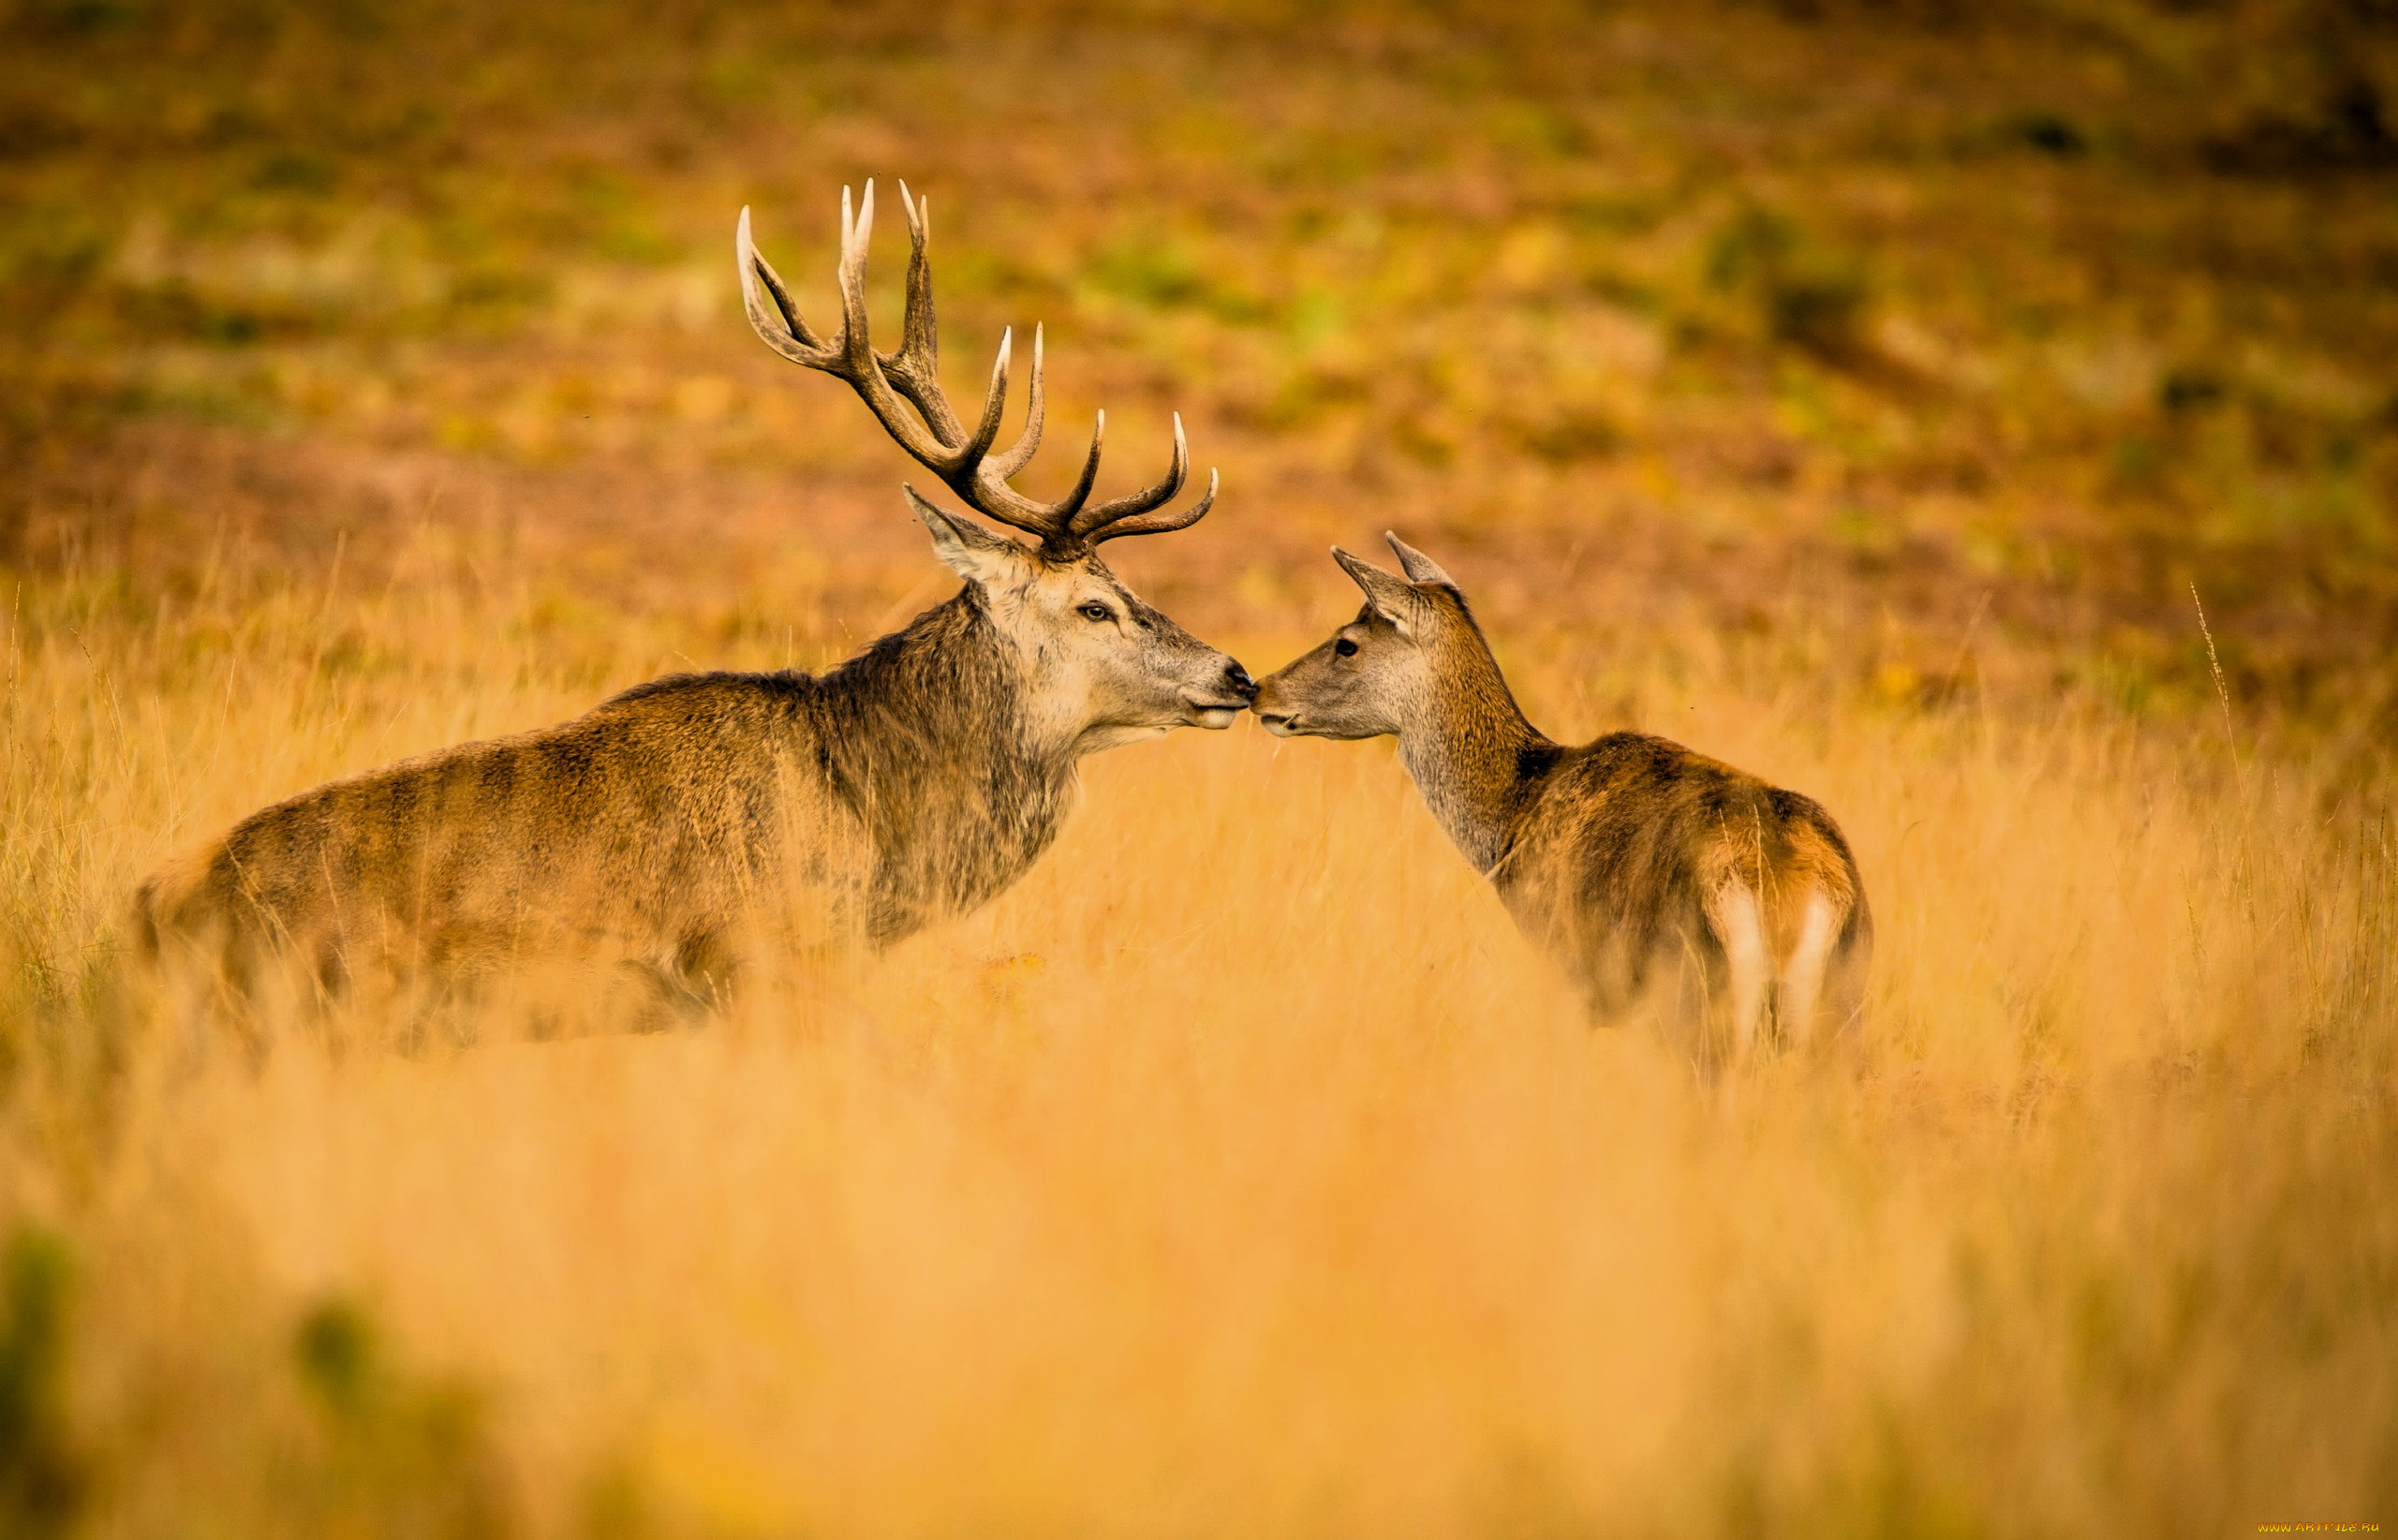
[{"xmin": 139, "ymin": 674, "xmax": 856, "ymax": 976}]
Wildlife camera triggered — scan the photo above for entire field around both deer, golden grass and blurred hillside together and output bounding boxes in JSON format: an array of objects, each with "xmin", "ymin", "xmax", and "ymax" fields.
[{"xmin": 0, "ymin": 0, "xmax": 2398, "ymax": 1537}]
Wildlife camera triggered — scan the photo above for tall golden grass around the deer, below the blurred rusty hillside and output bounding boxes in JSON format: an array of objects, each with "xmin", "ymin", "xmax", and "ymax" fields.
[{"xmin": 0, "ymin": 546, "xmax": 2398, "ymax": 1537}]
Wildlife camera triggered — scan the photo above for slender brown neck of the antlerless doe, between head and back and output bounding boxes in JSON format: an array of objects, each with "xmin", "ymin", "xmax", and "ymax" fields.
[{"xmin": 1398, "ymin": 636, "xmax": 1556, "ymax": 876}]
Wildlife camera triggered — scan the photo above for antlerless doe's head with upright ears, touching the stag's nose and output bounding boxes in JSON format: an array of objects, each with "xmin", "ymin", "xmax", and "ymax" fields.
[{"xmin": 1251, "ymin": 532, "xmax": 1482, "ymax": 739}]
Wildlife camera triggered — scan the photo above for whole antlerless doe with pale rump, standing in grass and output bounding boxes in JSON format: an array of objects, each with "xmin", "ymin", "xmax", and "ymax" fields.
[{"xmin": 1251, "ymin": 532, "xmax": 1873, "ymax": 1073}]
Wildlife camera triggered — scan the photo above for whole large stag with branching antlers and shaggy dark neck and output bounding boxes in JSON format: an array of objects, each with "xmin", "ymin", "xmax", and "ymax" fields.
[{"xmin": 134, "ymin": 183, "xmax": 1256, "ymax": 1000}]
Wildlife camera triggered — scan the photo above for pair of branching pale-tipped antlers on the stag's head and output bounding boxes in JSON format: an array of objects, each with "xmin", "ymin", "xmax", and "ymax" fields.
[{"xmin": 733, "ymin": 180, "xmax": 1216, "ymax": 555}]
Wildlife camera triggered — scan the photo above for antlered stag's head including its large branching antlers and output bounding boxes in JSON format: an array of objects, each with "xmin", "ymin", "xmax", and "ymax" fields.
[{"xmin": 736, "ymin": 183, "xmax": 1256, "ymax": 751}]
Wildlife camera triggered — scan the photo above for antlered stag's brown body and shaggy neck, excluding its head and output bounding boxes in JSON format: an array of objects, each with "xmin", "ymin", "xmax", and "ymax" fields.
[{"xmin": 137, "ymin": 580, "xmax": 1093, "ymax": 984}]
